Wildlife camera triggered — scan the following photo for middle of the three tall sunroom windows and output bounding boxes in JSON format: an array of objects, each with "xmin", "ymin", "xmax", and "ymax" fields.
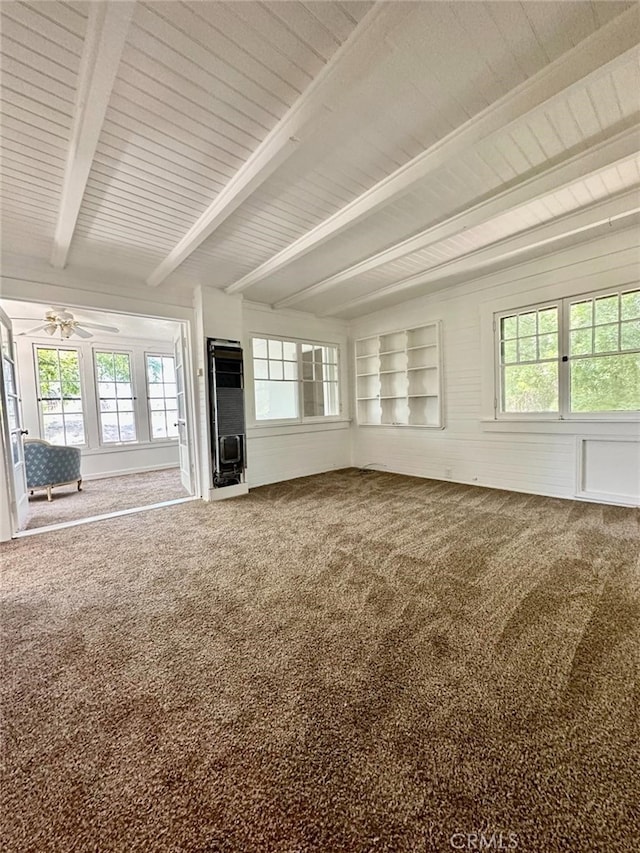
[{"xmin": 94, "ymin": 351, "xmax": 137, "ymax": 444}]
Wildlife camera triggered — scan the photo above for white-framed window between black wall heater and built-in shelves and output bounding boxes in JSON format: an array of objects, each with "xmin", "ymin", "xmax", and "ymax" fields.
[{"xmin": 252, "ymin": 338, "xmax": 340, "ymax": 421}]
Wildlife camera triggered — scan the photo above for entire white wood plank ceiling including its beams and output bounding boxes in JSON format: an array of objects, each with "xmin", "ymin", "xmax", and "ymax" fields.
[{"xmin": 0, "ymin": 0, "xmax": 640, "ymax": 317}]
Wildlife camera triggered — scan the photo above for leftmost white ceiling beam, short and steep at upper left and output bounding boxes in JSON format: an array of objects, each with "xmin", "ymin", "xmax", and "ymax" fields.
[{"xmin": 51, "ymin": 2, "xmax": 135, "ymax": 269}]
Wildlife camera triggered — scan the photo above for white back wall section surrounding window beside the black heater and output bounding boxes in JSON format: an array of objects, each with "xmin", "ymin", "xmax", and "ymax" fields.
[{"xmin": 242, "ymin": 302, "xmax": 351, "ymax": 487}]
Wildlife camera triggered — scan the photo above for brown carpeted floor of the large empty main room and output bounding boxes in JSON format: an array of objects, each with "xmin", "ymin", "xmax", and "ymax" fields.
[{"xmin": 1, "ymin": 470, "xmax": 640, "ymax": 853}]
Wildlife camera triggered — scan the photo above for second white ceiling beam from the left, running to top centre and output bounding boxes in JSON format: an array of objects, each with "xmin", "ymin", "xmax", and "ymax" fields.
[{"xmin": 147, "ymin": 3, "xmax": 412, "ymax": 287}]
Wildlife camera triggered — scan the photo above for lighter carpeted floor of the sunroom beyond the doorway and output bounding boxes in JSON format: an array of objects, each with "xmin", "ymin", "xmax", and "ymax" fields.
[{"xmin": 26, "ymin": 468, "xmax": 188, "ymax": 530}]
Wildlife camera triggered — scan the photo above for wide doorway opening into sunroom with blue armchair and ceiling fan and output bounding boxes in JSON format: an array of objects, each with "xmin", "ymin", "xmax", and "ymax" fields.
[{"xmin": 0, "ymin": 299, "xmax": 199, "ymax": 538}]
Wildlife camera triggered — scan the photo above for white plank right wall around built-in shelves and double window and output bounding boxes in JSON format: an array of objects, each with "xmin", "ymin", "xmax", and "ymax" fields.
[{"xmin": 350, "ymin": 230, "xmax": 640, "ymax": 504}]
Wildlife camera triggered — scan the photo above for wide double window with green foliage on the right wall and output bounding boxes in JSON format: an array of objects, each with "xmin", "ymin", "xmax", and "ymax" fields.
[{"xmin": 496, "ymin": 289, "xmax": 640, "ymax": 418}]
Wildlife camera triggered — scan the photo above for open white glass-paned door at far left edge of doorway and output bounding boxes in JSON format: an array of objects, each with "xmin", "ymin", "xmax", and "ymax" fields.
[{"xmin": 0, "ymin": 309, "xmax": 29, "ymax": 533}]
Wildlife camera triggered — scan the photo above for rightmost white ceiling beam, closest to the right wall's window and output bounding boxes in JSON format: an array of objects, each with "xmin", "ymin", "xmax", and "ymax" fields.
[{"xmin": 317, "ymin": 187, "xmax": 640, "ymax": 317}]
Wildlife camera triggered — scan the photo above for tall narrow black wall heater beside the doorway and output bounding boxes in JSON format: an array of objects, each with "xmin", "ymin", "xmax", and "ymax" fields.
[{"xmin": 207, "ymin": 338, "xmax": 246, "ymax": 488}]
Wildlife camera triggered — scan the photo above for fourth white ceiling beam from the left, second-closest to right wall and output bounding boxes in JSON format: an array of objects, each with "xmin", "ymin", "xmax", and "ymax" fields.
[{"xmin": 273, "ymin": 116, "xmax": 639, "ymax": 308}]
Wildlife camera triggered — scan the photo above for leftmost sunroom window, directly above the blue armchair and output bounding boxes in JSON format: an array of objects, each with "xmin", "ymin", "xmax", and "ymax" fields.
[{"xmin": 36, "ymin": 347, "xmax": 85, "ymax": 444}]
